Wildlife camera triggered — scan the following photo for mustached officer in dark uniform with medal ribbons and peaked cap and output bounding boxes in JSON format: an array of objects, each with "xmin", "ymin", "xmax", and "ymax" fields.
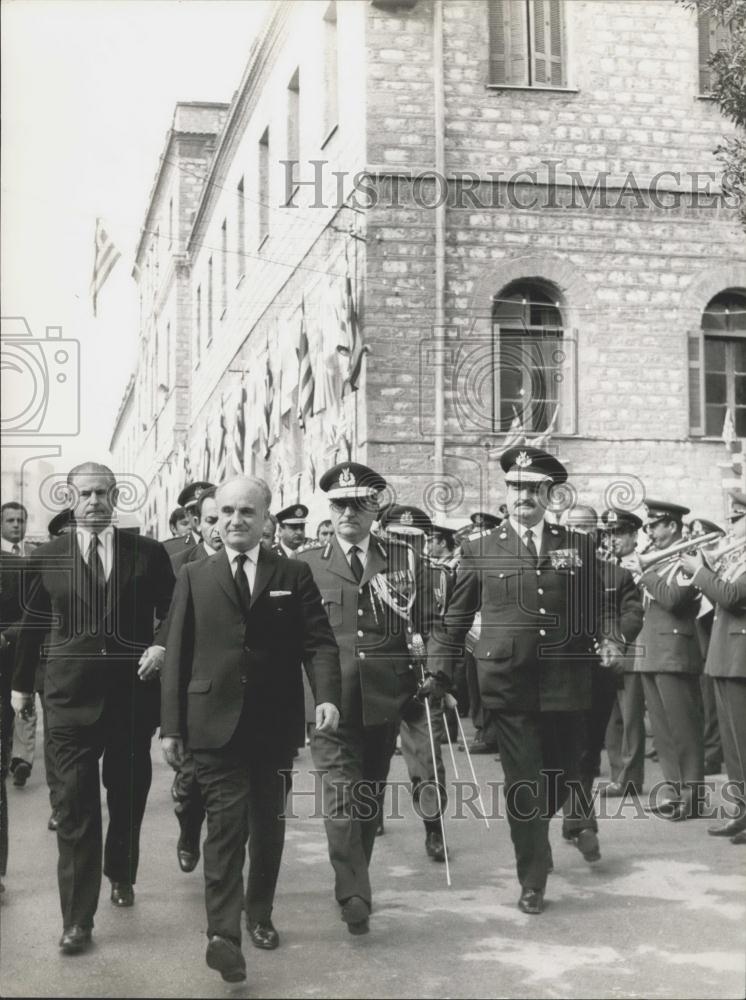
[{"xmin": 431, "ymin": 447, "xmax": 601, "ymax": 914}]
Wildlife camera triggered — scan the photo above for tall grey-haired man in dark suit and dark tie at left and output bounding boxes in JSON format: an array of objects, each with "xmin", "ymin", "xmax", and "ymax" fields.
[{"xmin": 13, "ymin": 462, "xmax": 174, "ymax": 954}]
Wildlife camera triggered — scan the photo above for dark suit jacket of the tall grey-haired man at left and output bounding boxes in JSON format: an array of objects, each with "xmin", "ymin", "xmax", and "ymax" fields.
[{"xmin": 13, "ymin": 528, "xmax": 174, "ymax": 728}]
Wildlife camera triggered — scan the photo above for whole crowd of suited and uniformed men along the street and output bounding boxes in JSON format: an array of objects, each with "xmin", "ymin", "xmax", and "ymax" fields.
[{"xmin": 0, "ymin": 458, "xmax": 746, "ymax": 982}]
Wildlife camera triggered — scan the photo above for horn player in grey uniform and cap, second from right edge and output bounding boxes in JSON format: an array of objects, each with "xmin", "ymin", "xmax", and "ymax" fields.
[{"xmin": 635, "ymin": 499, "xmax": 704, "ymax": 821}]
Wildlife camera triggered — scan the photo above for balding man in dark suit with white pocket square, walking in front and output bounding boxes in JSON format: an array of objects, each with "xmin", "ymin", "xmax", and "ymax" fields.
[{"xmin": 161, "ymin": 478, "xmax": 340, "ymax": 982}]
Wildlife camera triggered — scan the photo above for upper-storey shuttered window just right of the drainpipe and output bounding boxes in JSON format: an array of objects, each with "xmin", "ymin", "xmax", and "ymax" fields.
[{"xmin": 487, "ymin": 0, "xmax": 566, "ymax": 87}]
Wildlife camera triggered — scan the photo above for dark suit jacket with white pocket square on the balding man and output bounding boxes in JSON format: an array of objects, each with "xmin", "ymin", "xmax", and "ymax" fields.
[{"xmin": 161, "ymin": 547, "xmax": 340, "ymax": 750}]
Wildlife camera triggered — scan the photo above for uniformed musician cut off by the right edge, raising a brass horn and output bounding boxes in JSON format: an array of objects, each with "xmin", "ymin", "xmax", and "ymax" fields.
[{"xmin": 681, "ymin": 490, "xmax": 746, "ymax": 844}]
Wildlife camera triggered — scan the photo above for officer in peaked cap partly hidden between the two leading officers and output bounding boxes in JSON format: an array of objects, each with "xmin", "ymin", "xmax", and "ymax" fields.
[{"xmin": 379, "ymin": 504, "xmax": 447, "ymax": 862}]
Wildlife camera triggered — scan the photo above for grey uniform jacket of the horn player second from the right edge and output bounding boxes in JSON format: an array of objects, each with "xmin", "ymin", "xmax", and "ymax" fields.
[{"xmin": 635, "ymin": 567, "xmax": 702, "ymax": 674}]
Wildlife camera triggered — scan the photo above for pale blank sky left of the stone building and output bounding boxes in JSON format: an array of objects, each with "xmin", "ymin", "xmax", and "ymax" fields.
[{"xmin": 0, "ymin": 0, "xmax": 266, "ymax": 492}]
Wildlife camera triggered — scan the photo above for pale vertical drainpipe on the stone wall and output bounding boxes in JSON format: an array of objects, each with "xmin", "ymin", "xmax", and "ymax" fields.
[{"xmin": 433, "ymin": 0, "xmax": 446, "ymax": 478}]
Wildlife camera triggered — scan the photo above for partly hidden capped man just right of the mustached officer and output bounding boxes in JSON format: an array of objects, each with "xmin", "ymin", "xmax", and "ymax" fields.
[{"xmin": 599, "ymin": 507, "xmax": 645, "ymax": 798}]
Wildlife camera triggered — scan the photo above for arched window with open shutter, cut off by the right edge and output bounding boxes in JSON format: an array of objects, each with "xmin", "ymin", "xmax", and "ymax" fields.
[{"xmin": 692, "ymin": 288, "xmax": 746, "ymax": 437}]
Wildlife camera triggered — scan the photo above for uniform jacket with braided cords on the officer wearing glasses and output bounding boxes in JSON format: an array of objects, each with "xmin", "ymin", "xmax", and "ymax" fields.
[{"xmin": 298, "ymin": 535, "xmax": 428, "ymax": 726}]
